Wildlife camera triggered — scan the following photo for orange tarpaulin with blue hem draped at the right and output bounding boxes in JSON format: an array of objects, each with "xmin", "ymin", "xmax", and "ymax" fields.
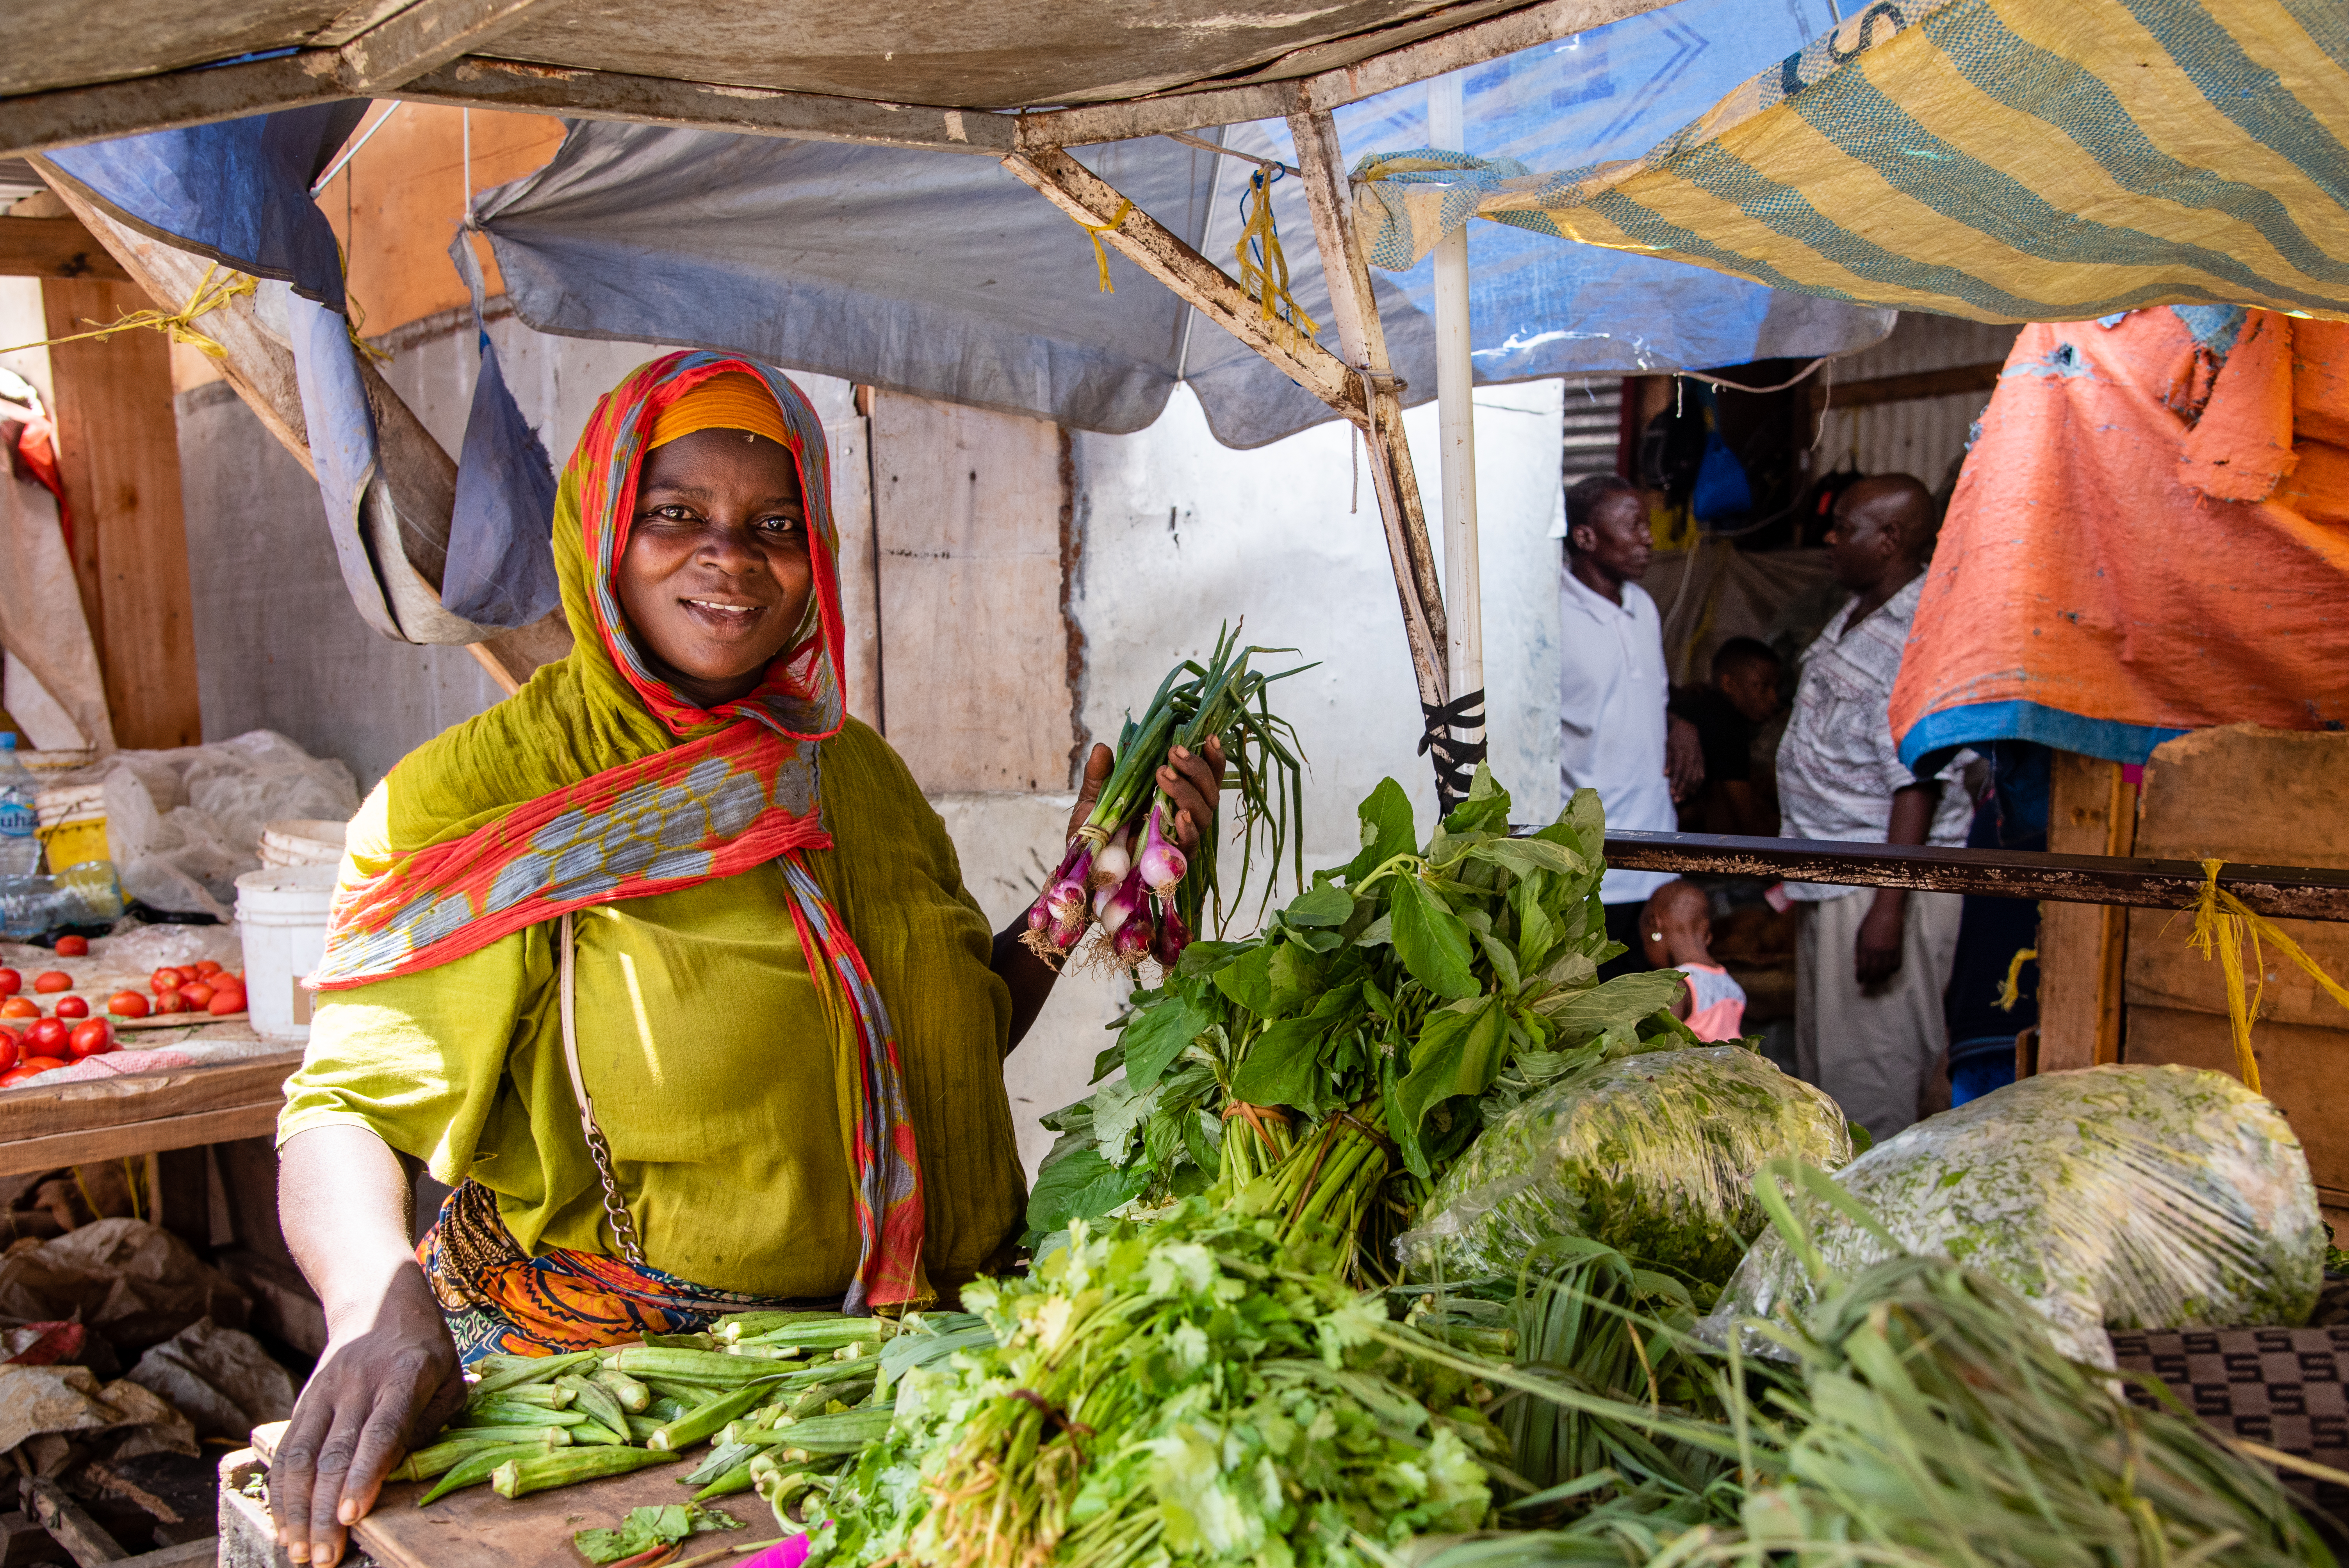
[{"xmin": 1891, "ymin": 305, "xmax": 2349, "ymax": 765}]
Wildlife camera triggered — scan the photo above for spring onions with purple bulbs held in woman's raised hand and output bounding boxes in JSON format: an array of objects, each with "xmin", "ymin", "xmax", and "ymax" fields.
[{"xmin": 1024, "ymin": 627, "xmax": 1311, "ymax": 972}]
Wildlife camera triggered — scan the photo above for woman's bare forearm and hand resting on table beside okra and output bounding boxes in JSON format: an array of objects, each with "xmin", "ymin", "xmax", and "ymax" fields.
[{"xmin": 270, "ymin": 1127, "xmax": 465, "ymax": 1568}]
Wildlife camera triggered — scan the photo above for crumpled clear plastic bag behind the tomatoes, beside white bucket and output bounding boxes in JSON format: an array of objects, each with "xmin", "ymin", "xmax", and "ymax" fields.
[{"xmin": 82, "ymin": 730, "xmax": 359, "ymax": 920}]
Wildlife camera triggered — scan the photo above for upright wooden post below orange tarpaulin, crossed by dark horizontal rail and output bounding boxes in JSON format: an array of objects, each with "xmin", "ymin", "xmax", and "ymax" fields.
[{"xmin": 2039, "ymin": 751, "xmax": 2138, "ymax": 1073}]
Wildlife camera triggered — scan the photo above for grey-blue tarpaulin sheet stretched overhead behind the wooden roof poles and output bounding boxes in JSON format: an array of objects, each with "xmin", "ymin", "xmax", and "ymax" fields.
[{"xmin": 474, "ymin": 0, "xmax": 1891, "ymax": 446}]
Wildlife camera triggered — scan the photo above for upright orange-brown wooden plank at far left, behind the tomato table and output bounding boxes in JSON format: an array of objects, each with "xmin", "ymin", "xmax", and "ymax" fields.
[{"xmin": 40, "ymin": 279, "xmax": 204, "ymax": 749}]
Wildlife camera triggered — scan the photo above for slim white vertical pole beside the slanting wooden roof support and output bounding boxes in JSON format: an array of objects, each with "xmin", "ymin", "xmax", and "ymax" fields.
[{"xmin": 1428, "ymin": 70, "xmax": 1485, "ymax": 742}]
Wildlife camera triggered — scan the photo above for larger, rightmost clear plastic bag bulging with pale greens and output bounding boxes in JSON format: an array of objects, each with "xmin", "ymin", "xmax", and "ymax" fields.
[{"xmin": 1703, "ymin": 1066, "xmax": 2326, "ymax": 1366}]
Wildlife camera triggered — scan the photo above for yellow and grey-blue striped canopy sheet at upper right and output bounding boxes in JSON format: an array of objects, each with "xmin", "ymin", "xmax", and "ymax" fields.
[{"xmin": 1355, "ymin": 0, "xmax": 2349, "ymax": 322}]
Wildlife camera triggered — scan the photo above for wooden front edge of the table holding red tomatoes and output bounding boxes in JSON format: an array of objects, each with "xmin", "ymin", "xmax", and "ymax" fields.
[{"xmin": 0, "ymin": 1047, "xmax": 301, "ymax": 1176}]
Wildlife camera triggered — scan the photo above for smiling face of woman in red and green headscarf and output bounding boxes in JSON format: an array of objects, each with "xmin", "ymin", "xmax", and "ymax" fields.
[{"xmin": 613, "ymin": 429, "xmax": 815, "ymax": 709}]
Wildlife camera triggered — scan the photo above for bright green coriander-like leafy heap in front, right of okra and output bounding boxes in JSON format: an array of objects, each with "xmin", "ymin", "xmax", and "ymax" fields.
[{"xmin": 811, "ymin": 1199, "xmax": 1503, "ymax": 1568}]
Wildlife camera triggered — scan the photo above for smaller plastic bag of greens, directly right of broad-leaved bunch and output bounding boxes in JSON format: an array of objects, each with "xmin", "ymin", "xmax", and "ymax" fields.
[{"xmin": 1395, "ymin": 1044, "xmax": 1851, "ymax": 1284}]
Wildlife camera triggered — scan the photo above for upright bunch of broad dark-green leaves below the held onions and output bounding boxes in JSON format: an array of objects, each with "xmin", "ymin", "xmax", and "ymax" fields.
[{"xmin": 1029, "ymin": 765, "xmax": 1696, "ymax": 1242}]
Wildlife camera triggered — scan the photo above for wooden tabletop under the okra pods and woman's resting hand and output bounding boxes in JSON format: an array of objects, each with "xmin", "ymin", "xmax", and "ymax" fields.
[{"xmin": 221, "ymin": 1422, "xmax": 777, "ymax": 1568}]
